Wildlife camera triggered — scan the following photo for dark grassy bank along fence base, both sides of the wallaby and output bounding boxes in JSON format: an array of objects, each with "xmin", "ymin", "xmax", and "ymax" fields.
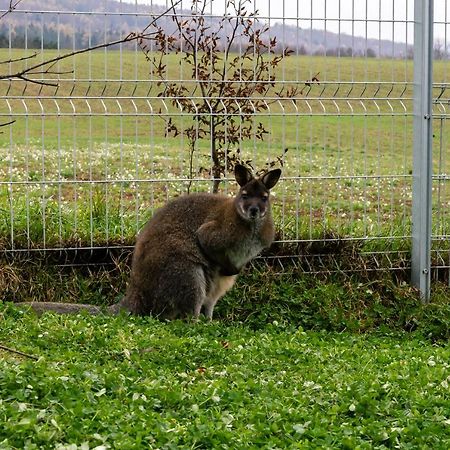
[{"xmin": 0, "ymin": 252, "xmax": 450, "ymax": 341}]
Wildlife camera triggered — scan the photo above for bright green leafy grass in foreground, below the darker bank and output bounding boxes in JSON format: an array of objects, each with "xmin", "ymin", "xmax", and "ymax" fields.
[{"xmin": 0, "ymin": 306, "xmax": 450, "ymax": 450}]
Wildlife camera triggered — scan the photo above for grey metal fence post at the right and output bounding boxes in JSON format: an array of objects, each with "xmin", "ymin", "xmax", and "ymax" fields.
[{"xmin": 411, "ymin": 0, "xmax": 433, "ymax": 301}]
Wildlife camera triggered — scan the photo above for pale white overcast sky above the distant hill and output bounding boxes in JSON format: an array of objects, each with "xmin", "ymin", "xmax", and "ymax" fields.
[{"xmin": 123, "ymin": 0, "xmax": 450, "ymax": 45}]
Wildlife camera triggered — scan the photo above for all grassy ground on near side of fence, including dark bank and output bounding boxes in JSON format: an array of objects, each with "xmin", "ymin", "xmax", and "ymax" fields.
[{"xmin": 0, "ymin": 253, "xmax": 450, "ymax": 450}]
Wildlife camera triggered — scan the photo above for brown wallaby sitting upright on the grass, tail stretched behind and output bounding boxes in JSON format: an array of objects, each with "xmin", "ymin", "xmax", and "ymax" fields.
[{"xmin": 22, "ymin": 164, "xmax": 281, "ymax": 319}]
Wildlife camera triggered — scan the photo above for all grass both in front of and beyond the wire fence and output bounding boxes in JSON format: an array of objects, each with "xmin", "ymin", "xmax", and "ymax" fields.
[{"xmin": 0, "ymin": 51, "xmax": 450, "ymax": 450}]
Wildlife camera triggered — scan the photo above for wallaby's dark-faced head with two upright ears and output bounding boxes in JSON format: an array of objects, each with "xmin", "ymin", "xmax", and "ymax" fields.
[{"xmin": 234, "ymin": 164, "xmax": 281, "ymax": 221}]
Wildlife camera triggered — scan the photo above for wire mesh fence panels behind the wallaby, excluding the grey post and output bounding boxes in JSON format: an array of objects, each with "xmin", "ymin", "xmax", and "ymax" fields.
[{"xmin": 0, "ymin": 0, "xmax": 449, "ymax": 294}]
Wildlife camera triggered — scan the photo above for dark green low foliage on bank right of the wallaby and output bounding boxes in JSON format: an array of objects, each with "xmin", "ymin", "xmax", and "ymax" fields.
[{"xmin": 215, "ymin": 270, "xmax": 450, "ymax": 341}]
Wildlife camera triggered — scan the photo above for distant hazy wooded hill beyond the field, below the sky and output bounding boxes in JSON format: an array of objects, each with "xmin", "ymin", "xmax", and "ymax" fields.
[{"xmin": 0, "ymin": 0, "xmax": 412, "ymax": 58}]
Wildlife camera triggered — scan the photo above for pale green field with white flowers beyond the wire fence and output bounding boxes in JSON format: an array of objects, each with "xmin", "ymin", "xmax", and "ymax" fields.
[{"xmin": 0, "ymin": 50, "xmax": 450, "ymax": 253}]
